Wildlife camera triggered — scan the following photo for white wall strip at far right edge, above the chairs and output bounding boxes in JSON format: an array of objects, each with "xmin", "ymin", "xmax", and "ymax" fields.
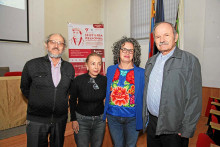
[{"xmin": 202, "ymin": 0, "xmax": 220, "ymax": 88}]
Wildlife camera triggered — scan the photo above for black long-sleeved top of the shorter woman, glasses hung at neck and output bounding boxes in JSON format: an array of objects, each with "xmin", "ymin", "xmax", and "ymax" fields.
[{"xmin": 69, "ymin": 73, "xmax": 107, "ymax": 121}]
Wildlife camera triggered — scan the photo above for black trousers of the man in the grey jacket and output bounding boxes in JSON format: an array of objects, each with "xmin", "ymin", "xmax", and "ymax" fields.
[{"xmin": 147, "ymin": 114, "xmax": 189, "ymax": 147}]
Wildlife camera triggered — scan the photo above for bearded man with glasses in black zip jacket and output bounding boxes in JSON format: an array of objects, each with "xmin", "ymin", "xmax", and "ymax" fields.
[{"xmin": 21, "ymin": 34, "xmax": 75, "ymax": 147}]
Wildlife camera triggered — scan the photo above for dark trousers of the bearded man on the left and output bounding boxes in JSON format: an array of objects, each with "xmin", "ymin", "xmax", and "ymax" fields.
[{"xmin": 26, "ymin": 119, "xmax": 67, "ymax": 147}]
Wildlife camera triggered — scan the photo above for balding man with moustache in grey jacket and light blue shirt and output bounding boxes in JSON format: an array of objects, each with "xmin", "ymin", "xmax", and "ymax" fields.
[{"xmin": 143, "ymin": 22, "xmax": 202, "ymax": 147}]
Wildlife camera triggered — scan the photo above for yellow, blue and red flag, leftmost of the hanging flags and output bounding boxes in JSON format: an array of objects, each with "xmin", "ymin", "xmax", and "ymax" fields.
[{"xmin": 149, "ymin": 0, "xmax": 155, "ymax": 58}]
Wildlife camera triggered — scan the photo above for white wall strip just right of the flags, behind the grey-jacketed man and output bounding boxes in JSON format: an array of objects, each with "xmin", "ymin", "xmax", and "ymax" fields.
[{"xmin": 184, "ymin": 0, "xmax": 206, "ymax": 64}]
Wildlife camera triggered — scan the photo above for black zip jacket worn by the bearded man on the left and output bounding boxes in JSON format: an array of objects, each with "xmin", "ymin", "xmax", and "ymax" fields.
[{"xmin": 20, "ymin": 55, "xmax": 75, "ymax": 123}]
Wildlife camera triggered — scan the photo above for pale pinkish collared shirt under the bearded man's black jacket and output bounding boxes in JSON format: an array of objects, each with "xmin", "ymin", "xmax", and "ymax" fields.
[{"xmin": 49, "ymin": 57, "xmax": 61, "ymax": 87}]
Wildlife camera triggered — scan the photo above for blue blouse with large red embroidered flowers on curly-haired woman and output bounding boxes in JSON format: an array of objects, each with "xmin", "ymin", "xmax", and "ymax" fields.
[{"xmin": 107, "ymin": 68, "xmax": 135, "ymax": 117}]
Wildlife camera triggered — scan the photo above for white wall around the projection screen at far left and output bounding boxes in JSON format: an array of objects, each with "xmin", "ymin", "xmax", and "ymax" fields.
[{"xmin": 0, "ymin": 0, "xmax": 44, "ymax": 71}]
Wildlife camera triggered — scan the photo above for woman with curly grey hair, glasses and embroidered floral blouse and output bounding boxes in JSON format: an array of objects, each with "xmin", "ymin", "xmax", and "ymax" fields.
[{"xmin": 103, "ymin": 37, "xmax": 144, "ymax": 147}]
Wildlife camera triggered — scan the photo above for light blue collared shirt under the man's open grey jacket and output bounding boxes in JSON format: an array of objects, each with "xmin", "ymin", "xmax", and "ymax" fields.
[{"xmin": 146, "ymin": 49, "xmax": 175, "ymax": 117}]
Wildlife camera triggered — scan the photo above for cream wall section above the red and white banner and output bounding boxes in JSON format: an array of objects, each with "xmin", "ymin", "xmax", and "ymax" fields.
[{"xmin": 45, "ymin": 0, "xmax": 103, "ymax": 61}]
